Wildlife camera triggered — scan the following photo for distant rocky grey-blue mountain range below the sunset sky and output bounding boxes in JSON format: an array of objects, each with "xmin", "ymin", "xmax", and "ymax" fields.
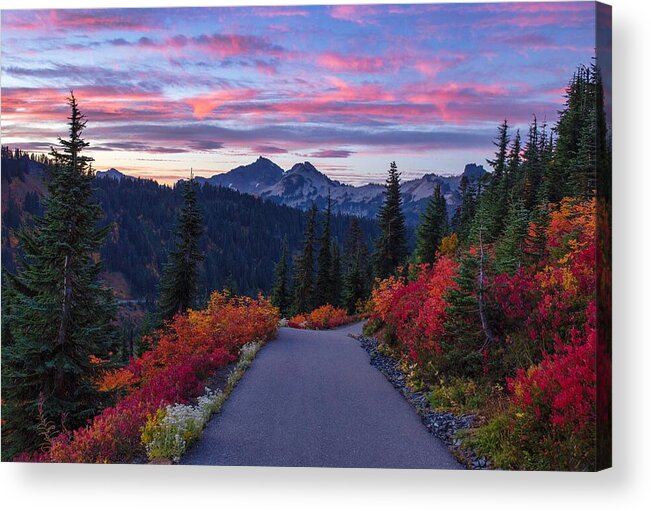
[{"xmin": 196, "ymin": 156, "xmax": 486, "ymax": 226}]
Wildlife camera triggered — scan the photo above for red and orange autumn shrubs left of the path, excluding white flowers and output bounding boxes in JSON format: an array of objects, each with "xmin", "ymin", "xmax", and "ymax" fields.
[{"xmin": 42, "ymin": 292, "xmax": 279, "ymax": 463}]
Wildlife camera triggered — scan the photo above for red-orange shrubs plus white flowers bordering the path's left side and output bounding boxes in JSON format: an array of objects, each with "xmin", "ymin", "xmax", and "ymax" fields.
[{"xmin": 25, "ymin": 292, "xmax": 279, "ymax": 463}]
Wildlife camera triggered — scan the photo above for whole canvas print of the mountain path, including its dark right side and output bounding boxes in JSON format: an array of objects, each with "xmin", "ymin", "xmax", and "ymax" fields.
[{"xmin": 1, "ymin": 2, "xmax": 612, "ymax": 471}]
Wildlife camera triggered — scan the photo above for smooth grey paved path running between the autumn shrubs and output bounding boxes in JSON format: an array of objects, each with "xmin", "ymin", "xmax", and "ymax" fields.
[{"xmin": 181, "ymin": 323, "xmax": 461, "ymax": 469}]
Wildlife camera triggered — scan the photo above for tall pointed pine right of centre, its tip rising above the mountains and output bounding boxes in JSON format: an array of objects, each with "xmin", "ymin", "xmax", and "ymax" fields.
[{"xmin": 374, "ymin": 162, "xmax": 408, "ymax": 278}]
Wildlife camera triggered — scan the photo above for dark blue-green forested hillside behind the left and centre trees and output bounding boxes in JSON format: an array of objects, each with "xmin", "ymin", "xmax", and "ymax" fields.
[{"xmin": 2, "ymin": 154, "xmax": 377, "ymax": 300}]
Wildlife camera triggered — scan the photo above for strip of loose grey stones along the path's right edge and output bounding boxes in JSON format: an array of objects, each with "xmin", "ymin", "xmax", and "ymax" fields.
[{"xmin": 356, "ymin": 336, "xmax": 491, "ymax": 470}]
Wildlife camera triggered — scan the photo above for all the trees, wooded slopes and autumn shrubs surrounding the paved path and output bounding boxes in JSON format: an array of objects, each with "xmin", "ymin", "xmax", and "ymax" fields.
[{"xmin": 2, "ymin": 66, "xmax": 611, "ymax": 470}]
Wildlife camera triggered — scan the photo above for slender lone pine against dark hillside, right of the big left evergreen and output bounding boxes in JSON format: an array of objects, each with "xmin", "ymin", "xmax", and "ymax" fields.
[{"xmin": 158, "ymin": 177, "xmax": 203, "ymax": 320}]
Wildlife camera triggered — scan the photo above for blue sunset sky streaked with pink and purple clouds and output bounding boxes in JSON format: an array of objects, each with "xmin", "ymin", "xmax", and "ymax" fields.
[{"xmin": 1, "ymin": 2, "xmax": 595, "ymax": 184}]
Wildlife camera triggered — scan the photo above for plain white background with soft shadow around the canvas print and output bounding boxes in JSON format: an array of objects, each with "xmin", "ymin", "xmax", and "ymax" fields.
[{"xmin": 0, "ymin": 0, "xmax": 651, "ymax": 511}]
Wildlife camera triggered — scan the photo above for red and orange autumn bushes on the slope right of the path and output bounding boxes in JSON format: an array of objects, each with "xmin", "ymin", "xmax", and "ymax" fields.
[{"xmin": 371, "ymin": 199, "xmax": 610, "ymax": 470}]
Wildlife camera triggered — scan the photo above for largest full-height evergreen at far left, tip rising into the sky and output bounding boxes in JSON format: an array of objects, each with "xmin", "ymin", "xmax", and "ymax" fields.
[{"xmin": 2, "ymin": 92, "xmax": 117, "ymax": 459}]
